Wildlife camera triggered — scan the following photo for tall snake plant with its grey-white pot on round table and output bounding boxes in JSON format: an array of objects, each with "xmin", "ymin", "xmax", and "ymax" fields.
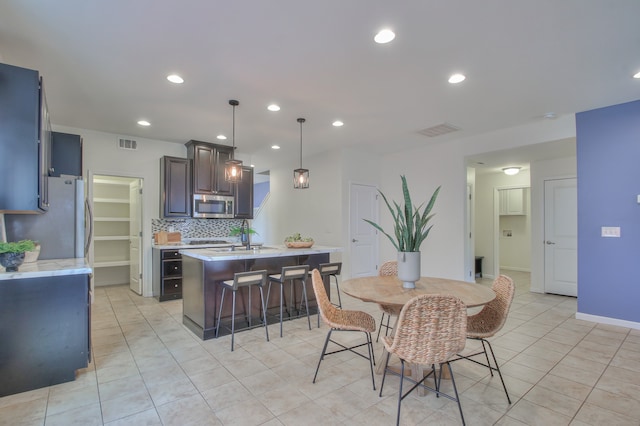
[{"xmin": 364, "ymin": 175, "xmax": 441, "ymax": 288}]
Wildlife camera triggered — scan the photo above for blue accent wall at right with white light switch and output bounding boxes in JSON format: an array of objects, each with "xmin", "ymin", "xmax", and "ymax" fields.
[{"xmin": 576, "ymin": 100, "xmax": 640, "ymax": 322}]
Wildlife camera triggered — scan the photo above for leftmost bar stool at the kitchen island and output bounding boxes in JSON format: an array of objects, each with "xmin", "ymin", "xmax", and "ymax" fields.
[{"xmin": 216, "ymin": 270, "xmax": 269, "ymax": 352}]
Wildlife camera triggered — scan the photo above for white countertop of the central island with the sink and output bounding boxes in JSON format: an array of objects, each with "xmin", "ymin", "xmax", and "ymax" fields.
[{"xmin": 180, "ymin": 245, "xmax": 342, "ymax": 261}]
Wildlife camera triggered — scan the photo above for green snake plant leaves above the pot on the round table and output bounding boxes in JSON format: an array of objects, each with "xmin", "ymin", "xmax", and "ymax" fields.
[{"xmin": 364, "ymin": 175, "xmax": 441, "ymax": 252}]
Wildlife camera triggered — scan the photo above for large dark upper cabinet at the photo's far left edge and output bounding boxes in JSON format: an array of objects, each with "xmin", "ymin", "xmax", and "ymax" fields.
[{"xmin": 0, "ymin": 64, "xmax": 51, "ymax": 213}]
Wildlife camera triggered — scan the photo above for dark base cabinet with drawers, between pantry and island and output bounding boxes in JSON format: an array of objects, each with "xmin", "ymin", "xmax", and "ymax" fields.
[{"xmin": 153, "ymin": 248, "xmax": 182, "ymax": 302}]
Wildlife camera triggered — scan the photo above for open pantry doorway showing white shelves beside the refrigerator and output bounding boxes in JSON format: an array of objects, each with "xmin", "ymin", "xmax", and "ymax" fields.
[{"xmin": 87, "ymin": 172, "xmax": 143, "ymax": 295}]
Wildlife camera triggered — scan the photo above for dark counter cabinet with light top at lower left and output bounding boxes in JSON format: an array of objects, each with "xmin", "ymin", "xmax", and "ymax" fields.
[{"xmin": 0, "ymin": 258, "xmax": 91, "ymax": 397}]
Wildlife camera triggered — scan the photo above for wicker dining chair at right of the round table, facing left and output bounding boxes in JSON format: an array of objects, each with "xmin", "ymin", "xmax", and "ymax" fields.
[{"xmin": 452, "ymin": 275, "xmax": 515, "ymax": 404}]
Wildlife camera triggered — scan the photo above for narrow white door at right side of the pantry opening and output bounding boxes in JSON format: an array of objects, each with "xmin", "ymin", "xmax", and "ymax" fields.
[{"xmin": 129, "ymin": 179, "xmax": 142, "ymax": 295}]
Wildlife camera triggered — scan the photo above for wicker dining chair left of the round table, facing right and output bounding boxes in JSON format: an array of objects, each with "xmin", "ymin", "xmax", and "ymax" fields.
[{"xmin": 311, "ymin": 269, "xmax": 376, "ymax": 390}]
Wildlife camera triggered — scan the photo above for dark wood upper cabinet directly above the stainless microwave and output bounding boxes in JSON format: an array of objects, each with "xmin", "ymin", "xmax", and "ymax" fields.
[{"xmin": 186, "ymin": 140, "xmax": 234, "ymax": 195}]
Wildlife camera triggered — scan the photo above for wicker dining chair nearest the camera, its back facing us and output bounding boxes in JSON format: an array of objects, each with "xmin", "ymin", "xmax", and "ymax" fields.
[{"xmin": 380, "ymin": 294, "xmax": 467, "ymax": 425}]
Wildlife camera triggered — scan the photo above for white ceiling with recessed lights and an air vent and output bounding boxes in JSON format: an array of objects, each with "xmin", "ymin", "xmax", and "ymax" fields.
[{"xmin": 0, "ymin": 0, "xmax": 640, "ymax": 171}]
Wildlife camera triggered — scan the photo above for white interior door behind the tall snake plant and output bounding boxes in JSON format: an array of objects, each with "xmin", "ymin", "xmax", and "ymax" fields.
[{"xmin": 349, "ymin": 183, "xmax": 378, "ymax": 278}]
